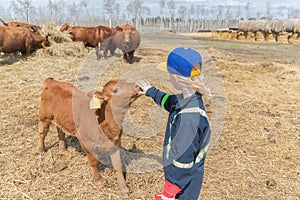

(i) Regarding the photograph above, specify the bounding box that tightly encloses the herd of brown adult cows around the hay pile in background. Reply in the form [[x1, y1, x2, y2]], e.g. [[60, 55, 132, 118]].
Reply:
[[0, 19, 141, 63]]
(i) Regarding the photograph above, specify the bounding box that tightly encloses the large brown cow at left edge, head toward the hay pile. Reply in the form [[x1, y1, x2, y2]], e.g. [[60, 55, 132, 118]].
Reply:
[[0, 26, 50, 56]]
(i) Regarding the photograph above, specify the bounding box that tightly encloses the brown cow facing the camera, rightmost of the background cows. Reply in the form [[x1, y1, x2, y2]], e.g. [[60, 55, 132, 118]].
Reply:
[[109, 24, 141, 63]]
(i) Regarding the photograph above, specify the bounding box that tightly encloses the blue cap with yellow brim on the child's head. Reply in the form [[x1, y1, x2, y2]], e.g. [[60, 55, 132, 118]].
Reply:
[[157, 47, 202, 77]]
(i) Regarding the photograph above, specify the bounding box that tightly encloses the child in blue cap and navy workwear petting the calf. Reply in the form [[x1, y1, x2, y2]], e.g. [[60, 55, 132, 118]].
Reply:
[[137, 48, 210, 200]]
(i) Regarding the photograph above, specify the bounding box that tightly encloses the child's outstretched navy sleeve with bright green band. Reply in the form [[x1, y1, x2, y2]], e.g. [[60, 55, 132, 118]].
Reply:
[[146, 87, 177, 112]]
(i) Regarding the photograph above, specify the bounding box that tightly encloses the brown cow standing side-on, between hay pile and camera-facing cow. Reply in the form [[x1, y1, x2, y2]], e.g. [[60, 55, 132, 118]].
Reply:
[[60, 23, 114, 59]]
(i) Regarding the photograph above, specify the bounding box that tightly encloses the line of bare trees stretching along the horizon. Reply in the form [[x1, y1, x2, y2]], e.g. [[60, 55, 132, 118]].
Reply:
[[0, 0, 300, 32]]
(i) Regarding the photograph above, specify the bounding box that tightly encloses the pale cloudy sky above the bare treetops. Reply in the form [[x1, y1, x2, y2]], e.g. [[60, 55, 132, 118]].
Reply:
[[0, 0, 300, 17]]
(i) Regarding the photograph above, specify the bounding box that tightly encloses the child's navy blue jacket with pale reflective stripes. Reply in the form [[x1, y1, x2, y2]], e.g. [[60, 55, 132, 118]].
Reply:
[[146, 87, 211, 189]]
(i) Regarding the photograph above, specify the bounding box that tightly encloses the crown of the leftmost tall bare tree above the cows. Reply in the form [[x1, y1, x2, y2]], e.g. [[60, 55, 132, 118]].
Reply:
[[10, 0, 36, 23]]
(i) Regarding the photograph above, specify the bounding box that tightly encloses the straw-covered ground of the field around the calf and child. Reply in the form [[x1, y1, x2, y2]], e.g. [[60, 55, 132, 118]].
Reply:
[[0, 33, 300, 200]]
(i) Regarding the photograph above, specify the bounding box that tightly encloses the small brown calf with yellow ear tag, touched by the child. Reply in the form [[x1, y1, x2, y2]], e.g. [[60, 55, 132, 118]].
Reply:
[[38, 78, 140, 195]]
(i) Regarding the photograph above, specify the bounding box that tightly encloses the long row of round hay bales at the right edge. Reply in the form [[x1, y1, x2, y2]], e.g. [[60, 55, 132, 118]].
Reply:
[[212, 18, 300, 43]]
